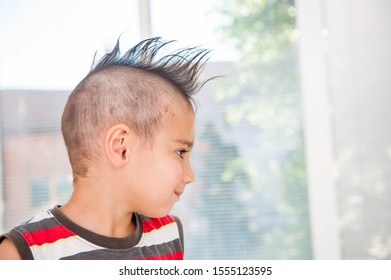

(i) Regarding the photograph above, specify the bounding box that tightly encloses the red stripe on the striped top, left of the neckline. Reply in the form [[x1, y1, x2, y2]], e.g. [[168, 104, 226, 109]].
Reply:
[[23, 226, 75, 246]]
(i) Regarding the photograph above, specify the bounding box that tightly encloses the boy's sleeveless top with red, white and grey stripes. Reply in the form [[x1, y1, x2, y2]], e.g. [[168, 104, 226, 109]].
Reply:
[[0, 206, 183, 260]]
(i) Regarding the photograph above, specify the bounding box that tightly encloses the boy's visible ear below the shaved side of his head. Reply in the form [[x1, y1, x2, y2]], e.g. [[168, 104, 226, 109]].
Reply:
[[105, 124, 131, 167]]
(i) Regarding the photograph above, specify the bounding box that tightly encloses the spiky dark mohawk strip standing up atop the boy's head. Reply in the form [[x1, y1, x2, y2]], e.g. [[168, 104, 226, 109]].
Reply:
[[90, 37, 213, 105]]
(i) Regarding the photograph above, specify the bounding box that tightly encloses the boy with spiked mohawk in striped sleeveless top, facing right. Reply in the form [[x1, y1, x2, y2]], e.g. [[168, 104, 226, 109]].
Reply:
[[0, 38, 213, 259]]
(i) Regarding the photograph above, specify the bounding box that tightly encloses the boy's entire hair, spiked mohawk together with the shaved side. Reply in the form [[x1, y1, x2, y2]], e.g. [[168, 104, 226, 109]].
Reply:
[[61, 38, 213, 180]]
